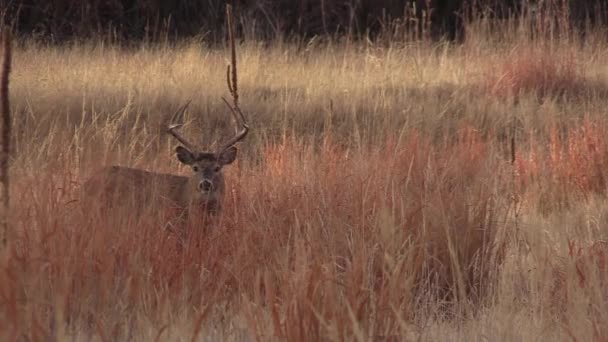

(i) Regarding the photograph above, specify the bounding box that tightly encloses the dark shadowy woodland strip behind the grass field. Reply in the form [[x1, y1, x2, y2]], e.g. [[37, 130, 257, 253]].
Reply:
[[0, 0, 608, 42]]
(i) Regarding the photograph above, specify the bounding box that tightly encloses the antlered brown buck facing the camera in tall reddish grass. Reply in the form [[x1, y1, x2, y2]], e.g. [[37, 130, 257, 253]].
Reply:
[[84, 7, 249, 222]]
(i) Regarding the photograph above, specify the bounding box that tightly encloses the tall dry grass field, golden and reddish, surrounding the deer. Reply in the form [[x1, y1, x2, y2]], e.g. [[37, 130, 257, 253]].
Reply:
[[0, 20, 608, 341]]
